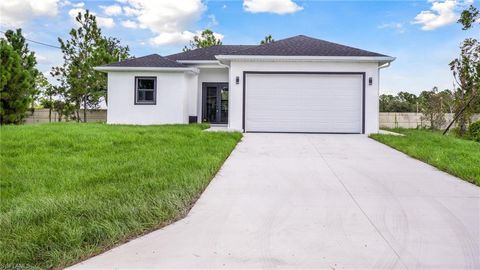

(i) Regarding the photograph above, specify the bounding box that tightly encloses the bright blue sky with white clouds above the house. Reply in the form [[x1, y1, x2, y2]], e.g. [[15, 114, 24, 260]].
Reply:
[[0, 0, 480, 94]]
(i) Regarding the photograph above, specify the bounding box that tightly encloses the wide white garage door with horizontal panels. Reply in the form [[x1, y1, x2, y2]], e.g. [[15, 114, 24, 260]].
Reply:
[[245, 73, 363, 133]]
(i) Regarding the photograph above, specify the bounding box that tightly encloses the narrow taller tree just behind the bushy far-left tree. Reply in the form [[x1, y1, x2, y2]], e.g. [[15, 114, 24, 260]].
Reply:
[[5, 28, 40, 113]]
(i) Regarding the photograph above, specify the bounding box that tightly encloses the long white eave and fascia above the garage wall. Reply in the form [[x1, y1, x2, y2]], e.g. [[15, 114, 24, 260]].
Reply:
[[215, 55, 395, 63]]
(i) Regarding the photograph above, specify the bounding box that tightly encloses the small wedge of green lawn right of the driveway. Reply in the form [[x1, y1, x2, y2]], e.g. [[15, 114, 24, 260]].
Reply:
[[370, 129, 480, 186]]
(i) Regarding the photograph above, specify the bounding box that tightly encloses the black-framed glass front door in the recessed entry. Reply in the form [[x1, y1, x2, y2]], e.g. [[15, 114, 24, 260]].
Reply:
[[202, 83, 228, 124]]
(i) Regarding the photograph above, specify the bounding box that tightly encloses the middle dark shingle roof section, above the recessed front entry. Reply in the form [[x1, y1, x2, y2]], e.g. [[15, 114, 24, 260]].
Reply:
[[166, 45, 257, 61]]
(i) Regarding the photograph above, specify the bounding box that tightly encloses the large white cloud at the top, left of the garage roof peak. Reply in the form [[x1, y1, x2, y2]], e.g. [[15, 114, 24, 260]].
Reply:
[[117, 0, 223, 45]]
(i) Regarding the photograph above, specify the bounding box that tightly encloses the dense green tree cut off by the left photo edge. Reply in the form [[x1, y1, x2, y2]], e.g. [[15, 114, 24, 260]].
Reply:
[[0, 39, 32, 124]]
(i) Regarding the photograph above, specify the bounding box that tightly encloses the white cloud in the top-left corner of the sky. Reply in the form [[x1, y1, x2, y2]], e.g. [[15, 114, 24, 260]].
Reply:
[[0, 0, 59, 27]]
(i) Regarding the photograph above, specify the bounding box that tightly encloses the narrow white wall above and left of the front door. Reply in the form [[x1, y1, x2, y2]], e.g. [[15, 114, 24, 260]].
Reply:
[[195, 67, 228, 123]]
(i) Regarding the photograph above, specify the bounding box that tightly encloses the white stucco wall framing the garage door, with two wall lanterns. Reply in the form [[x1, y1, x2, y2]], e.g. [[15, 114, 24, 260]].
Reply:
[[228, 61, 379, 134]]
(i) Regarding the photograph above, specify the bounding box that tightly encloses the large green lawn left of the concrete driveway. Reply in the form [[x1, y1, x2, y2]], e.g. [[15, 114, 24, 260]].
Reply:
[[0, 123, 242, 269]]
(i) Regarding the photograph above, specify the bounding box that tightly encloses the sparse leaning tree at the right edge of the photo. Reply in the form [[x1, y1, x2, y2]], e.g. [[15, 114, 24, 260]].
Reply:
[[443, 6, 480, 136]]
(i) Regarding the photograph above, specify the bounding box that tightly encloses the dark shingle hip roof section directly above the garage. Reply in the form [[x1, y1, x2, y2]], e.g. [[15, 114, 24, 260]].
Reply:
[[225, 35, 386, 56]]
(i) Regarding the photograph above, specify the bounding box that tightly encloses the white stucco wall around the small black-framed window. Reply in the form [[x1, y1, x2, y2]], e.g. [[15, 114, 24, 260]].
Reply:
[[107, 71, 190, 125]]
